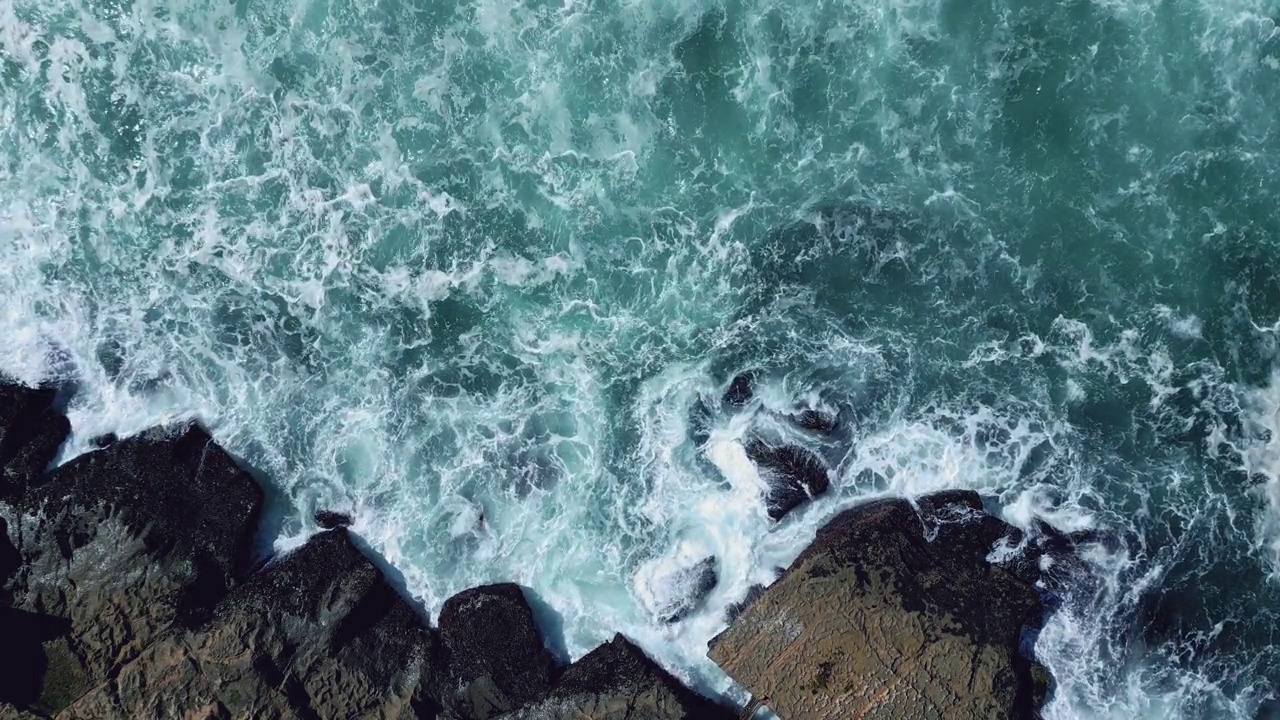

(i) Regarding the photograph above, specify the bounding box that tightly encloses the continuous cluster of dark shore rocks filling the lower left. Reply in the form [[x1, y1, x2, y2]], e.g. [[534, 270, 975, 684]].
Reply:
[[0, 384, 732, 720]]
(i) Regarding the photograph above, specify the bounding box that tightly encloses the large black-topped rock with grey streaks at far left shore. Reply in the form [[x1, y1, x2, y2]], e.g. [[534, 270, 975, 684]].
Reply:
[[0, 428, 262, 712]]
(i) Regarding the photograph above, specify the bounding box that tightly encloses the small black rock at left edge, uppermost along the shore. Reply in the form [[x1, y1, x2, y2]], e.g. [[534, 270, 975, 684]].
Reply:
[[0, 380, 72, 498]]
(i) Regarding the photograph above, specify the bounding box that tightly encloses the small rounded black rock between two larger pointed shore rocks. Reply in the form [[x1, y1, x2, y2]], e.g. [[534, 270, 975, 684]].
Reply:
[[438, 583, 553, 720]]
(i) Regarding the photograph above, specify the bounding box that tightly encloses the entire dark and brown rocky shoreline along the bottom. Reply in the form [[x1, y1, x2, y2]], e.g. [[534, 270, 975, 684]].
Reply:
[[0, 383, 1048, 720]]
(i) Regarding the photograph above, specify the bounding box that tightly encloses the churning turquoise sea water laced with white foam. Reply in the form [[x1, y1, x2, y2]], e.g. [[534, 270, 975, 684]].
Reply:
[[0, 0, 1280, 719]]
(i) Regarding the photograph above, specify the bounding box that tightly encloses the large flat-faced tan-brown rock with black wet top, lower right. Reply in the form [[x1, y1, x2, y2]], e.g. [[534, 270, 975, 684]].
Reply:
[[710, 492, 1047, 720]]
